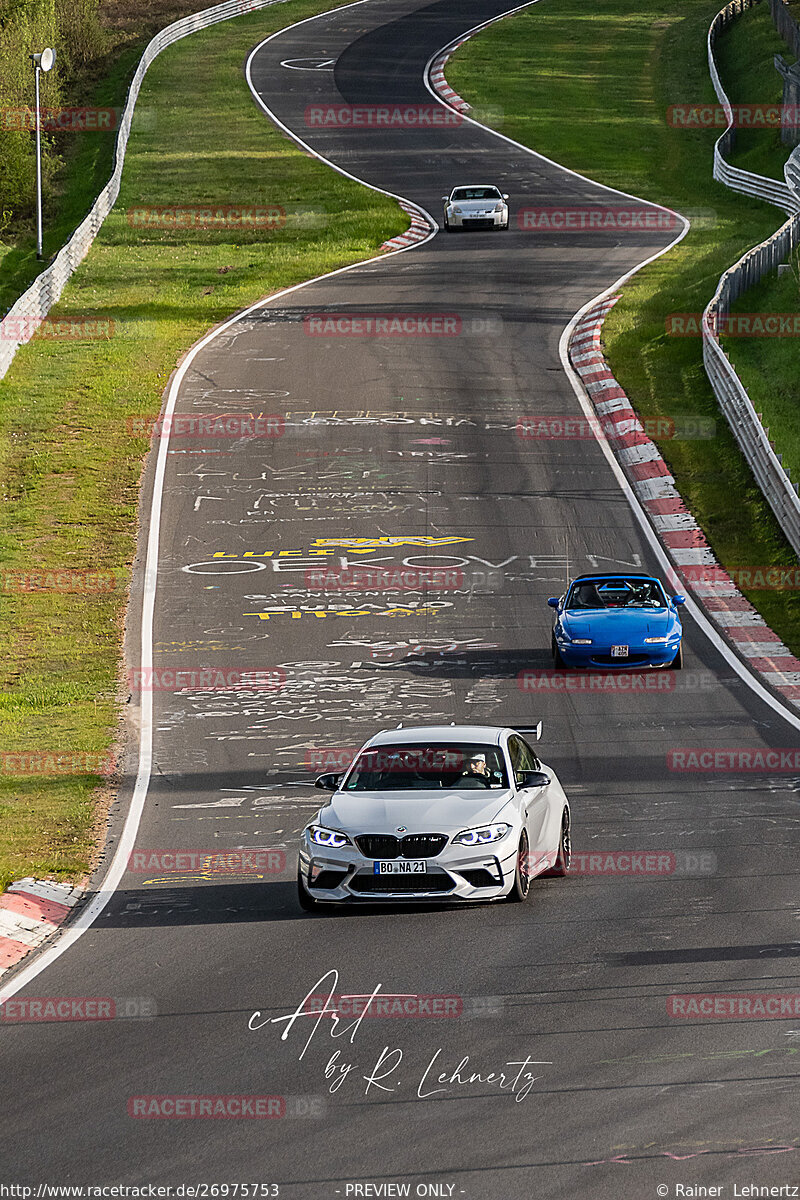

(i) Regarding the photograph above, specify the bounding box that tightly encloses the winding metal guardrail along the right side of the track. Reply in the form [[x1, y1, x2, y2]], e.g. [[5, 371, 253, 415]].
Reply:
[[703, 0, 800, 557]]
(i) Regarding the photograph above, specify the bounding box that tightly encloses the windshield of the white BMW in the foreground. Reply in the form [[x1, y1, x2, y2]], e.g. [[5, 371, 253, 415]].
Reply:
[[343, 742, 509, 792]]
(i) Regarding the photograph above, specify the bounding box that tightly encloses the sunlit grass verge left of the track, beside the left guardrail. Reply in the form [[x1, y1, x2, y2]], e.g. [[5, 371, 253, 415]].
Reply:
[[0, 0, 408, 887]]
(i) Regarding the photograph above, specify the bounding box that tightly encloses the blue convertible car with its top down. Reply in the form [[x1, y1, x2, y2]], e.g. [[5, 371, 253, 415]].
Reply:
[[547, 574, 686, 670]]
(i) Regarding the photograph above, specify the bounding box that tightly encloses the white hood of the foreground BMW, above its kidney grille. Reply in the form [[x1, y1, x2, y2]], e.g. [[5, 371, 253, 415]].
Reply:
[[319, 787, 513, 835]]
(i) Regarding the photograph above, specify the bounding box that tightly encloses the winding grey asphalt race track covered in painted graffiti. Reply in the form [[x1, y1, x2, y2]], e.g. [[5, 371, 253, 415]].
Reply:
[[2, 0, 800, 1200]]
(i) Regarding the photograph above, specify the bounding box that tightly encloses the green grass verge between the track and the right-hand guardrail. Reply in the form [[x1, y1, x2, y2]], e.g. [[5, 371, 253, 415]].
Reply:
[[447, 0, 800, 653]]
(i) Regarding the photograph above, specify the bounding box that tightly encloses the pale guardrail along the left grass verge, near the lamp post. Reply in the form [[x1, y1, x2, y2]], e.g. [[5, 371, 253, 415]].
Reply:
[[0, 0, 283, 379]]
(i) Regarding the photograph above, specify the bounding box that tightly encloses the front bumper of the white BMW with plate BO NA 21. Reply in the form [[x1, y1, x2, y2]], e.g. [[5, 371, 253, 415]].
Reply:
[[299, 830, 519, 904]]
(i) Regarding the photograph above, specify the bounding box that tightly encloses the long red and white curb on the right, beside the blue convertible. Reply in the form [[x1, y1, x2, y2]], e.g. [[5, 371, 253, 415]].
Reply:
[[570, 295, 800, 708]]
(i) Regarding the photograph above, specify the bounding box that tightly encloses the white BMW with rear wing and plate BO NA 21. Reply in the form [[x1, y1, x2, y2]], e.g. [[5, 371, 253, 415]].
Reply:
[[297, 725, 571, 911]]
